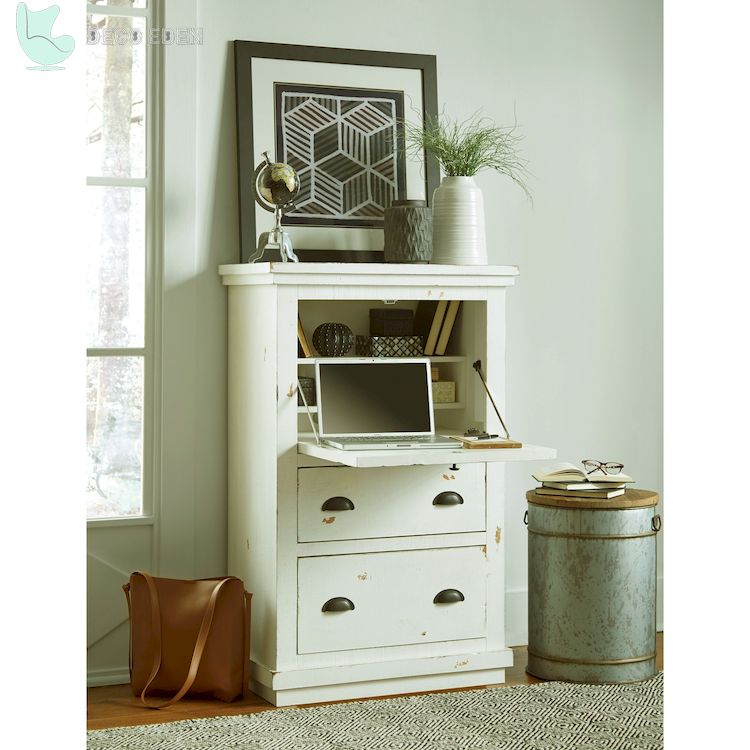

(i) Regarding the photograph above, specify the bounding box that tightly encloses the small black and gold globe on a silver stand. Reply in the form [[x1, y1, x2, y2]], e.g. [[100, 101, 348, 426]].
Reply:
[[249, 151, 300, 263]]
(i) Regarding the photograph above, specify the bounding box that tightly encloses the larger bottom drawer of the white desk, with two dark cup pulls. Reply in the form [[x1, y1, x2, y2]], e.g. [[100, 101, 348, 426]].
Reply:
[[297, 547, 488, 654]]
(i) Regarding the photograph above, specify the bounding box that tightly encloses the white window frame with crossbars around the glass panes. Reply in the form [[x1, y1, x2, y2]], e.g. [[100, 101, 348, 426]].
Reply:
[[86, 0, 164, 528]]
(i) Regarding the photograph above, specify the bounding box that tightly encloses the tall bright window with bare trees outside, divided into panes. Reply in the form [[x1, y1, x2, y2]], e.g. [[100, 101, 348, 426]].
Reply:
[[86, 0, 157, 519]]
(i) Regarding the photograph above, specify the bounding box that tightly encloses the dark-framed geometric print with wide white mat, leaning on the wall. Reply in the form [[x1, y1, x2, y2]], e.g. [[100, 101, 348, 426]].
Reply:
[[234, 41, 440, 262]]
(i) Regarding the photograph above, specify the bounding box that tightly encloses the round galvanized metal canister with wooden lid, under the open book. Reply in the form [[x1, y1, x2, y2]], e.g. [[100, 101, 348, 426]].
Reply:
[[526, 490, 661, 683]]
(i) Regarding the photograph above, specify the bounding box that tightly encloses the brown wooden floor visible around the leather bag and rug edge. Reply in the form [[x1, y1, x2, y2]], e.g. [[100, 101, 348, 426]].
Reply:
[[87, 633, 664, 729]]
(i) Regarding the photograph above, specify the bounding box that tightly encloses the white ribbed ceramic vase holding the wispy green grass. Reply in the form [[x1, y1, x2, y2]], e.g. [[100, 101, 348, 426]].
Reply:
[[432, 177, 487, 266]]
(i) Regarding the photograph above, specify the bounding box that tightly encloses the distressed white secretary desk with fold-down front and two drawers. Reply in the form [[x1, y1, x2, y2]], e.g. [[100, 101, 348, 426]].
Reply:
[[219, 263, 555, 706]]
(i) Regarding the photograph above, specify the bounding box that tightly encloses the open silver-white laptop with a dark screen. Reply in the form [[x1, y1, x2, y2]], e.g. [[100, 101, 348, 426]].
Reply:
[[315, 357, 460, 450]]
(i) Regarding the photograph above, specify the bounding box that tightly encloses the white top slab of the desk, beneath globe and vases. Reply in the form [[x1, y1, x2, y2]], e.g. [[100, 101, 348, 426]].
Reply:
[[219, 263, 518, 286]]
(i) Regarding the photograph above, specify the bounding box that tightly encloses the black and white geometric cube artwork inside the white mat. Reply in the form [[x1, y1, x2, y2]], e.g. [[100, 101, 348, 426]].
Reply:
[[275, 83, 406, 227]]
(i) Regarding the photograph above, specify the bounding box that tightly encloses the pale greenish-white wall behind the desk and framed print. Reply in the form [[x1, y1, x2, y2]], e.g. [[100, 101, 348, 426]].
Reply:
[[162, 0, 662, 644]]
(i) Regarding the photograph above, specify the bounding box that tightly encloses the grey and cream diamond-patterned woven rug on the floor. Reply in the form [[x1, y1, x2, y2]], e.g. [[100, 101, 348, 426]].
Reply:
[[87, 673, 663, 750]]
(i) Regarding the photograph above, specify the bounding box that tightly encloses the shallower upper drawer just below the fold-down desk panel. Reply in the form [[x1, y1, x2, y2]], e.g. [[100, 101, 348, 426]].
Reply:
[[297, 464, 485, 542]]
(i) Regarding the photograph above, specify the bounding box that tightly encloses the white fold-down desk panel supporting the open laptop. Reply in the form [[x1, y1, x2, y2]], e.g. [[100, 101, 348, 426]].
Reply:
[[297, 436, 557, 469]]
